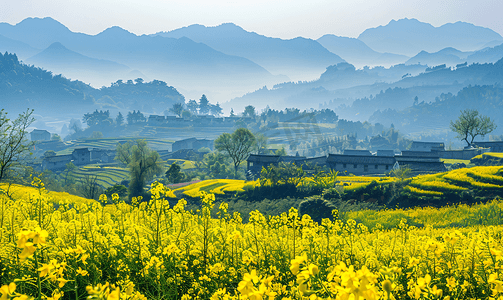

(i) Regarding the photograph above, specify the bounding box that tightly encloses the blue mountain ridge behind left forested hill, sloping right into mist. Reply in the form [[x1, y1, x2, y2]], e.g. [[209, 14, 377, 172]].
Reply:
[[0, 18, 287, 101]]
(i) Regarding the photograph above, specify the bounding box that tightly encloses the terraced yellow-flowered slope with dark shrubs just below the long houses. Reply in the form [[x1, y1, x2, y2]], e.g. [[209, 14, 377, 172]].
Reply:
[[173, 166, 503, 206]]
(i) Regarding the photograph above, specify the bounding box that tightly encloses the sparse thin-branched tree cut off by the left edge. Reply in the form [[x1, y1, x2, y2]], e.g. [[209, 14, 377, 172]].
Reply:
[[0, 109, 35, 182]]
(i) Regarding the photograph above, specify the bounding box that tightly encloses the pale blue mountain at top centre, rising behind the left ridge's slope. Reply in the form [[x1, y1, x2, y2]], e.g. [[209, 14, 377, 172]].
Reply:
[[155, 23, 344, 81]]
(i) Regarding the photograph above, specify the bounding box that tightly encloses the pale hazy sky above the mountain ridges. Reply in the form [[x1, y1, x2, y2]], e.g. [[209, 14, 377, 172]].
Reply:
[[0, 0, 503, 39]]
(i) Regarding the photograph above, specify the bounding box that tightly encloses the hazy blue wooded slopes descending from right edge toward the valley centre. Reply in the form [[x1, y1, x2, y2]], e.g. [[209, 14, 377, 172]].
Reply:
[[227, 55, 503, 116]]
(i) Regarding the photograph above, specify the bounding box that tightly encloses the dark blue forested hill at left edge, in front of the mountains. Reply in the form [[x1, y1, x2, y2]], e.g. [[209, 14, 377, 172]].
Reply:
[[0, 53, 185, 116]]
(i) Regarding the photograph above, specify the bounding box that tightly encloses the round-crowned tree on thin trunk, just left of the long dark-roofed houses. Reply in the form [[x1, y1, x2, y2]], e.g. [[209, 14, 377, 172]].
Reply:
[[215, 128, 255, 177]]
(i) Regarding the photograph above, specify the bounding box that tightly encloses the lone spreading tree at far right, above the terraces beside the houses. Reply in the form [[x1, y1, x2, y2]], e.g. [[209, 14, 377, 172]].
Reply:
[[450, 109, 496, 146]]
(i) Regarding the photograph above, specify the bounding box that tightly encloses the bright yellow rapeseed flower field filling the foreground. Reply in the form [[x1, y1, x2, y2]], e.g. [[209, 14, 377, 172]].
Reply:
[[0, 180, 503, 300]]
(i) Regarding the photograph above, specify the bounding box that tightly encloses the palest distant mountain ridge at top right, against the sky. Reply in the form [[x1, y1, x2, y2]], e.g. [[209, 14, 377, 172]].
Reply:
[[358, 18, 503, 56]]
